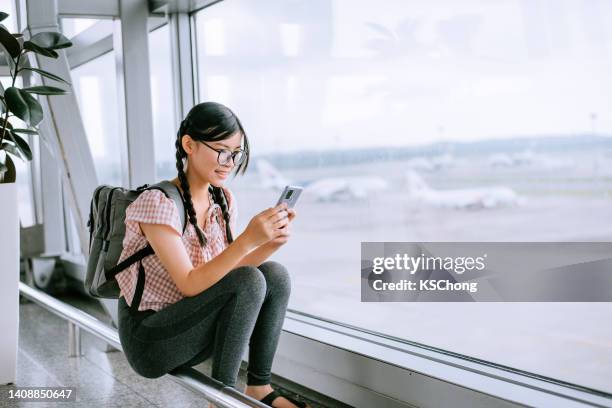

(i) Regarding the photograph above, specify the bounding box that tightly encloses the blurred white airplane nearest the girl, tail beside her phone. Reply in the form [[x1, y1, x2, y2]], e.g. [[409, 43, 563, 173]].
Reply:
[[257, 159, 389, 201]]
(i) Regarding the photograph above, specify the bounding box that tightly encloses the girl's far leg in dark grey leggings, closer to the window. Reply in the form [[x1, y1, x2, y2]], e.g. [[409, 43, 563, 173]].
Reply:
[[247, 261, 291, 385]]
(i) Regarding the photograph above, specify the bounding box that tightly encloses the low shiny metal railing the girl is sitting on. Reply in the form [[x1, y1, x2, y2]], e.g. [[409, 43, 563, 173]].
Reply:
[[19, 282, 269, 408]]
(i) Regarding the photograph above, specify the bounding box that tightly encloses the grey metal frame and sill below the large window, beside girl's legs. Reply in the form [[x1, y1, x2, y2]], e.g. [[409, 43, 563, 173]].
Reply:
[[274, 311, 612, 407]]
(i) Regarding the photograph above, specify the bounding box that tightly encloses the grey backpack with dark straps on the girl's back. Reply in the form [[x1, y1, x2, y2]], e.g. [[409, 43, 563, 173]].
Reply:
[[85, 180, 187, 302]]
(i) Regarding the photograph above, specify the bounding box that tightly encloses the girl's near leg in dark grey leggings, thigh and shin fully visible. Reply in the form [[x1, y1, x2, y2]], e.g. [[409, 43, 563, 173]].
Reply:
[[119, 266, 266, 387]]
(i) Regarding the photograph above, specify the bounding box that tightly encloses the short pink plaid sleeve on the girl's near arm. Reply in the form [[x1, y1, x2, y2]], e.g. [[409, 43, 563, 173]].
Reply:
[[125, 190, 182, 235]]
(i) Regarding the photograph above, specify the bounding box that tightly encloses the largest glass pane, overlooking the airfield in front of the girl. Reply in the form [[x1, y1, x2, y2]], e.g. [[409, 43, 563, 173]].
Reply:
[[196, 0, 612, 392]]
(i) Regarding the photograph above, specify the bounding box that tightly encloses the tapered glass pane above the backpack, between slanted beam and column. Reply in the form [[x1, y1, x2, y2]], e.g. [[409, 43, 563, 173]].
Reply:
[[71, 51, 125, 186]]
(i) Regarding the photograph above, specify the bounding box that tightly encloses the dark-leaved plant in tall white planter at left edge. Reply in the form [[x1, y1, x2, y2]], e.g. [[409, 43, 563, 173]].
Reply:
[[0, 12, 72, 384]]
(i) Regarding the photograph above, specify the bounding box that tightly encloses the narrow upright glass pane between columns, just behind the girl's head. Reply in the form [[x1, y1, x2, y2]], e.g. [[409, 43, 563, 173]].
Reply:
[[149, 25, 178, 180]]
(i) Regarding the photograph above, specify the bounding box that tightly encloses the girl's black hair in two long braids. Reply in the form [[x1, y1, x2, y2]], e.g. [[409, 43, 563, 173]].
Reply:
[[175, 102, 249, 247]]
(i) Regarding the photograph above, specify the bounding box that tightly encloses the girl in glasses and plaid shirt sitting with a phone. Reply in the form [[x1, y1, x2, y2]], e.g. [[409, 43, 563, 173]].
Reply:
[[116, 102, 309, 408]]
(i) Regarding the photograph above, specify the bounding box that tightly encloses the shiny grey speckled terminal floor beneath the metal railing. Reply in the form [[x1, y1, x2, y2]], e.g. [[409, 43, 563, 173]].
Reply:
[[0, 295, 346, 408]]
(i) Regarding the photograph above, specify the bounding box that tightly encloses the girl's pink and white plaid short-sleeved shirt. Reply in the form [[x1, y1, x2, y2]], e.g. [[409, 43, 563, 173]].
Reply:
[[115, 187, 237, 311]]
